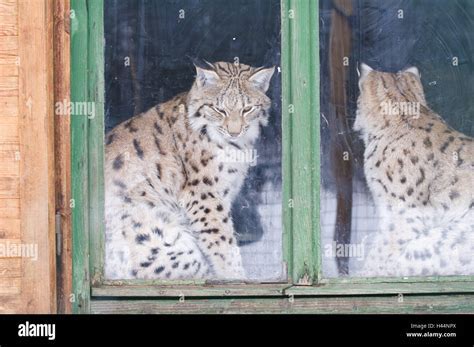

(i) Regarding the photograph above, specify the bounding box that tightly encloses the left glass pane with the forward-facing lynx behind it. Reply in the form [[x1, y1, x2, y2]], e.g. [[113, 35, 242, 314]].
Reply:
[[105, 0, 286, 281]]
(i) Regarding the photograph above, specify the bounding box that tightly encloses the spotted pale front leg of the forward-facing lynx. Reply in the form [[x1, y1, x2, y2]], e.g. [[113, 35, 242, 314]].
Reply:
[[186, 191, 246, 280]]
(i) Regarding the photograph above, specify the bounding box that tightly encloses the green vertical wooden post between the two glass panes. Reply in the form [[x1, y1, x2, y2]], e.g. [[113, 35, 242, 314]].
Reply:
[[289, 0, 319, 285]]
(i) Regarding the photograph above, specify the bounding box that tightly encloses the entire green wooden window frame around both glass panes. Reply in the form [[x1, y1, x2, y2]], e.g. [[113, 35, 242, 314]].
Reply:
[[71, 0, 474, 313]]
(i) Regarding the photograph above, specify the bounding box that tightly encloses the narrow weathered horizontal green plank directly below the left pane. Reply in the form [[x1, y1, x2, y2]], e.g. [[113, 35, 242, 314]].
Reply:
[[92, 284, 289, 297]]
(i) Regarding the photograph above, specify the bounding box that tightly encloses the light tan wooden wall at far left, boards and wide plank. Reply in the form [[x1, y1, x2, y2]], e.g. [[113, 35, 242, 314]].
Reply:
[[0, 0, 56, 313]]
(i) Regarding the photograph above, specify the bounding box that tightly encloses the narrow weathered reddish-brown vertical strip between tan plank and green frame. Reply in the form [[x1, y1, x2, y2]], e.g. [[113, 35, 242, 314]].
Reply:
[[53, 0, 72, 313]]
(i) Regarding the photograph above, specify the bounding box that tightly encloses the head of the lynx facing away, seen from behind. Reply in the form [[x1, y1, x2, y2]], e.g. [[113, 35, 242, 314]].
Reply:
[[354, 63, 426, 142]]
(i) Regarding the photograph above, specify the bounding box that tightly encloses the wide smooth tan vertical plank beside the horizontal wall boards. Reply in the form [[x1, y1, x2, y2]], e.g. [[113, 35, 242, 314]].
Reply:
[[18, 0, 56, 313]]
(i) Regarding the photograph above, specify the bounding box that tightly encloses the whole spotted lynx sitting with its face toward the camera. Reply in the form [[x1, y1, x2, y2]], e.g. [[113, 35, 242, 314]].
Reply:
[[105, 62, 274, 279]]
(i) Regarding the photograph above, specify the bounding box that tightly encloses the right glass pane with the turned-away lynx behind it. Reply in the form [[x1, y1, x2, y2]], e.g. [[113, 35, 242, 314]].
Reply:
[[320, 0, 474, 277]]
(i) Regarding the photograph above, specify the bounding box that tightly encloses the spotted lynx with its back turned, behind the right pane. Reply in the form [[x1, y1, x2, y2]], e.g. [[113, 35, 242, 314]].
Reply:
[[354, 64, 474, 276]]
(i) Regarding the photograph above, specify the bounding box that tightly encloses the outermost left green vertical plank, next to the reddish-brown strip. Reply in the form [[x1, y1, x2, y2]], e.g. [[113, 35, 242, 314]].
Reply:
[[71, 0, 91, 313]]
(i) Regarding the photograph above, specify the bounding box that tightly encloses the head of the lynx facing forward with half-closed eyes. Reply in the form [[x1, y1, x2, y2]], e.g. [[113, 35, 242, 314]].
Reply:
[[188, 62, 275, 144]]
